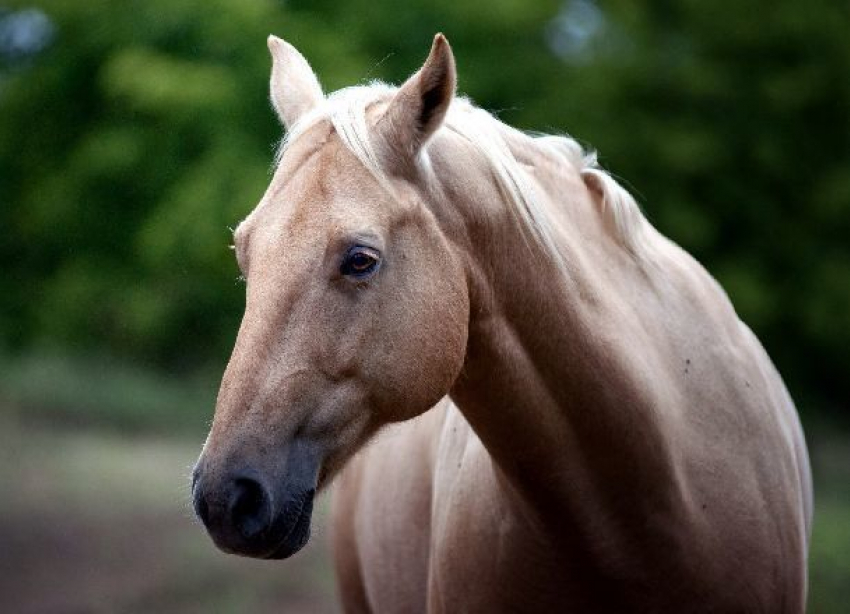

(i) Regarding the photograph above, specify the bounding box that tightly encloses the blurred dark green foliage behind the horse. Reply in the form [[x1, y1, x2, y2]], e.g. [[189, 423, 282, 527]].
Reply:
[[0, 0, 850, 418]]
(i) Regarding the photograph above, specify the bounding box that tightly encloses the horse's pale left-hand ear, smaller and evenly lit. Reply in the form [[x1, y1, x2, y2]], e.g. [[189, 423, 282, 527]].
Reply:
[[268, 35, 325, 130]]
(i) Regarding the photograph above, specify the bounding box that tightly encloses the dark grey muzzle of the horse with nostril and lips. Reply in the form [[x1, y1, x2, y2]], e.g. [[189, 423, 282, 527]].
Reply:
[[192, 445, 318, 559]]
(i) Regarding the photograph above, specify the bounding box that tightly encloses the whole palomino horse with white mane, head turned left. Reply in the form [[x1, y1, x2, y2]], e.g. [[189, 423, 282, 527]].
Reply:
[[193, 35, 812, 613]]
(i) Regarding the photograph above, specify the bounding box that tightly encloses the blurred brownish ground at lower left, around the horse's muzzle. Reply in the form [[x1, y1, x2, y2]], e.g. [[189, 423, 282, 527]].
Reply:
[[0, 419, 338, 614]]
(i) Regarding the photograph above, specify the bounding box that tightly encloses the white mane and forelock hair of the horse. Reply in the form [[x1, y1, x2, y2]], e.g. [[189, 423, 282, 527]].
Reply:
[[275, 82, 647, 265]]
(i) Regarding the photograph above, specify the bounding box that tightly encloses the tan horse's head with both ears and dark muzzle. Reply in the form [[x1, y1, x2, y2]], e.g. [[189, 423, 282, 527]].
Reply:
[[193, 35, 469, 558]]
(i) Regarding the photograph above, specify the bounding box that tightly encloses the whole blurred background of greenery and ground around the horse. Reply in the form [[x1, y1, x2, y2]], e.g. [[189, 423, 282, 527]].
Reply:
[[0, 0, 850, 612]]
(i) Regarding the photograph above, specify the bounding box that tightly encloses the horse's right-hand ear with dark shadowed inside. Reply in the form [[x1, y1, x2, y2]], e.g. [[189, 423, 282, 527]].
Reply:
[[379, 34, 457, 155]]
